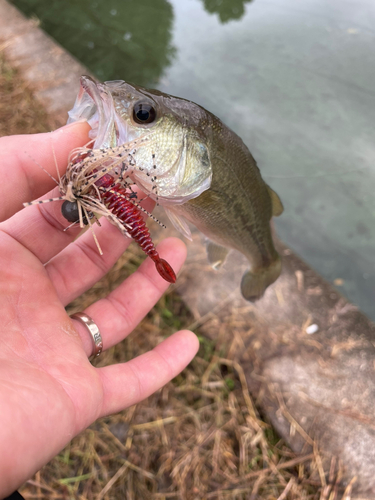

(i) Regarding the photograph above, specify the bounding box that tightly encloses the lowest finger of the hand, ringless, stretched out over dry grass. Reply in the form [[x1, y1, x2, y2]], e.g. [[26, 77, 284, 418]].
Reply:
[[98, 330, 199, 416]]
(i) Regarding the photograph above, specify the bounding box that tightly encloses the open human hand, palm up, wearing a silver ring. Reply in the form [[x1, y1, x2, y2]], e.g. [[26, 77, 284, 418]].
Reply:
[[0, 123, 198, 498]]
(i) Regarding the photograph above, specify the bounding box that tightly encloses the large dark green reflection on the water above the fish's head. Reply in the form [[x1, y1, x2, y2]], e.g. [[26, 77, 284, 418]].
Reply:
[[12, 0, 175, 85]]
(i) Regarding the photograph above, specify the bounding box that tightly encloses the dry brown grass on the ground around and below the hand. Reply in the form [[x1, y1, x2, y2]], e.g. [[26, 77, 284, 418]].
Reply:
[[0, 51, 350, 500]]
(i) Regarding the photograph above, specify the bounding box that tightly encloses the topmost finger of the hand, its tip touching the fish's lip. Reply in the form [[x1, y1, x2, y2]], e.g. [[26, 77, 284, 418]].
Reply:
[[0, 122, 90, 221]]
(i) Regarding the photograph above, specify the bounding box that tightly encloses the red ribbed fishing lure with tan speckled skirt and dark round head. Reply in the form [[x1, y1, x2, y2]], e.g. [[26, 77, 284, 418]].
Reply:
[[24, 145, 176, 283]]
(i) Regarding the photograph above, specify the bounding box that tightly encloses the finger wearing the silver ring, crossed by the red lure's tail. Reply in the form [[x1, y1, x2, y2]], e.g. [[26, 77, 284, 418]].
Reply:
[[70, 238, 186, 356]]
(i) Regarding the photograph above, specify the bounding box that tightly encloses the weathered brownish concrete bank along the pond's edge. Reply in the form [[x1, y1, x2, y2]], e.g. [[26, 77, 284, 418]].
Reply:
[[0, 0, 375, 498]]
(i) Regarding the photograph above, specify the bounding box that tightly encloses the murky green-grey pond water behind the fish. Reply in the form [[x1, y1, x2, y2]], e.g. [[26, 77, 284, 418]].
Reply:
[[9, 0, 375, 319]]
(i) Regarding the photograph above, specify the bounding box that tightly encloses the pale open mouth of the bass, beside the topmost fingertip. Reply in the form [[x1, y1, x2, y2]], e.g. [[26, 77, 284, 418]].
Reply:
[[67, 76, 118, 149]]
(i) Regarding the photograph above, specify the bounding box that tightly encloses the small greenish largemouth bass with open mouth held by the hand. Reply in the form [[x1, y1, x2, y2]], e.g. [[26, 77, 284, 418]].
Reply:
[[68, 76, 283, 302]]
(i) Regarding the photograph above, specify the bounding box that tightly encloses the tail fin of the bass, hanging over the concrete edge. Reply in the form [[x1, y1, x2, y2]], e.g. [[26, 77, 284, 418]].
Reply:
[[241, 256, 281, 302]]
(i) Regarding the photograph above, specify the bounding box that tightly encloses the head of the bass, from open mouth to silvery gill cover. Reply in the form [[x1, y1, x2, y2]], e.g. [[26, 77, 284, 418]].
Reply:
[[68, 76, 212, 206]]
